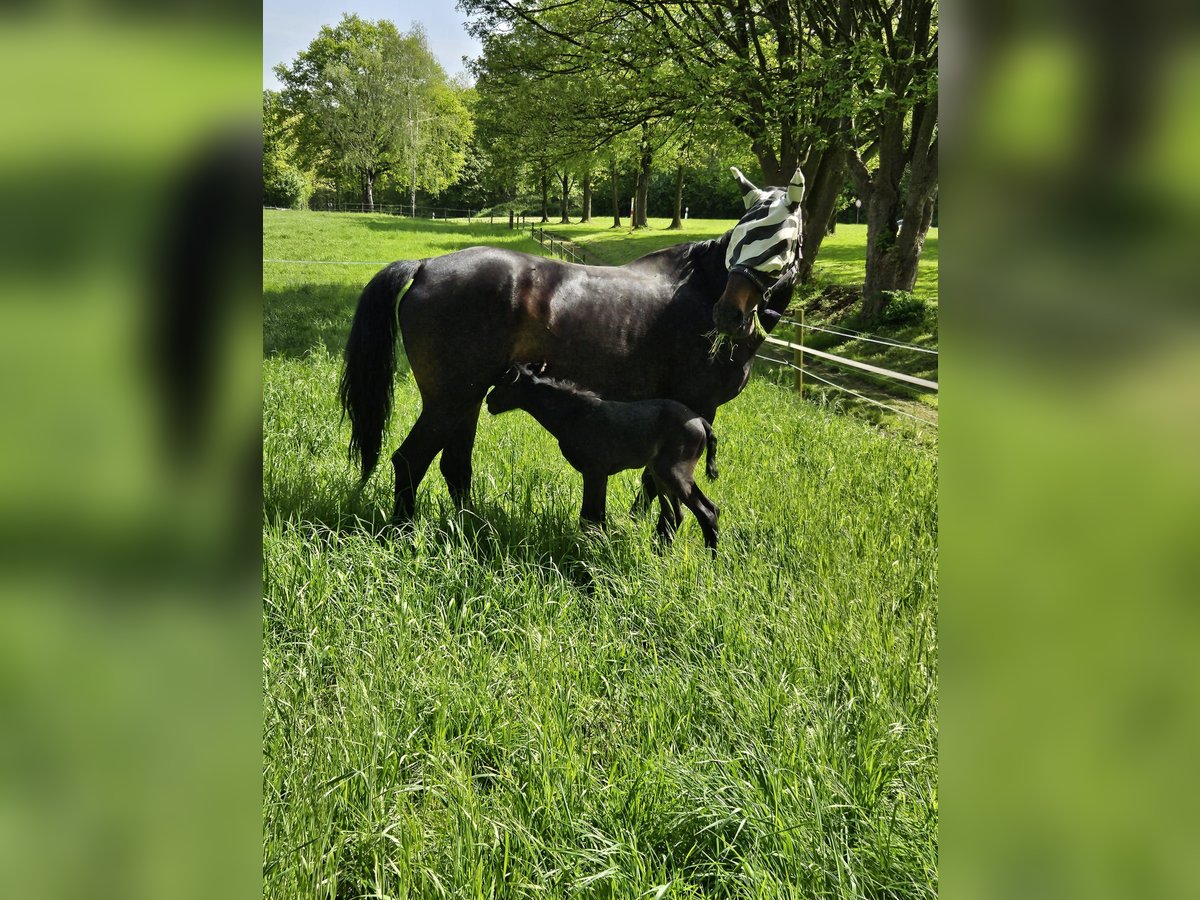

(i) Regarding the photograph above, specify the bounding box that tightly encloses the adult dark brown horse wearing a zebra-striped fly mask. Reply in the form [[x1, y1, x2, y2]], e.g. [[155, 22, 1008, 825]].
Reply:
[[340, 168, 804, 523]]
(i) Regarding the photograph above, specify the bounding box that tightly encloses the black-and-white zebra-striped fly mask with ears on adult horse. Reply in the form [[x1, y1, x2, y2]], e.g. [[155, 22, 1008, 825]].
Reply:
[[725, 168, 804, 275]]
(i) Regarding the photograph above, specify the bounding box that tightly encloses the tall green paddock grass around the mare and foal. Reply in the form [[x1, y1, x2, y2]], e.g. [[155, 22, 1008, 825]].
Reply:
[[263, 211, 937, 898]]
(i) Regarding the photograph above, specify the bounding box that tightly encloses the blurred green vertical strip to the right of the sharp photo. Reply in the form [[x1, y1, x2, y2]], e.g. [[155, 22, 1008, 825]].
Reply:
[[940, 4, 1200, 898]]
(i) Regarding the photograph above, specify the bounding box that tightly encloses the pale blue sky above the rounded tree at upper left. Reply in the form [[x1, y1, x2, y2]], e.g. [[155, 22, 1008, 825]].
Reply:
[[263, 0, 480, 90]]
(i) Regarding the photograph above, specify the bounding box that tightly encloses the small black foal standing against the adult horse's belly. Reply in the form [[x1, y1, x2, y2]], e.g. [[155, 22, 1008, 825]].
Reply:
[[487, 366, 720, 553]]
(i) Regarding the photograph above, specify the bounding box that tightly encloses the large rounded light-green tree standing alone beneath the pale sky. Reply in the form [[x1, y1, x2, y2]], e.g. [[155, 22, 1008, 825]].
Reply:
[[275, 14, 470, 211]]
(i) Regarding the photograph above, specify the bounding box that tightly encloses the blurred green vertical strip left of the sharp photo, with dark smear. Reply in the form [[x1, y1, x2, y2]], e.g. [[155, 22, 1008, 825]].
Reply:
[[0, 5, 262, 898]]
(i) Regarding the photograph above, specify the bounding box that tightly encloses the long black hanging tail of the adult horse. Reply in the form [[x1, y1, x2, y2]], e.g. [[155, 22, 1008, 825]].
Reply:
[[338, 259, 422, 482]]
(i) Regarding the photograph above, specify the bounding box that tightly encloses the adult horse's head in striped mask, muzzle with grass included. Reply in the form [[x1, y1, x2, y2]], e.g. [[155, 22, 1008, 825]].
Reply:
[[713, 168, 804, 337]]
